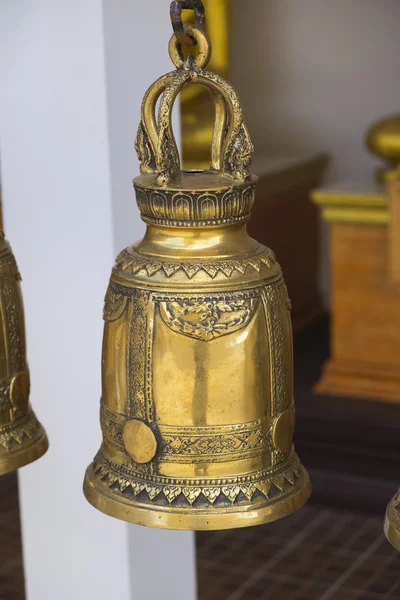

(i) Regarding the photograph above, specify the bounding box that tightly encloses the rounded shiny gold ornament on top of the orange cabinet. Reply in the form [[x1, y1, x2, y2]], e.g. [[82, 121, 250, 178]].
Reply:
[[367, 115, 400, 181]]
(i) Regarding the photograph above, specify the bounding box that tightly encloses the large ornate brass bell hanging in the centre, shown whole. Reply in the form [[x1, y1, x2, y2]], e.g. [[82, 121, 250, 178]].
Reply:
[[84, 2, 310, 530]]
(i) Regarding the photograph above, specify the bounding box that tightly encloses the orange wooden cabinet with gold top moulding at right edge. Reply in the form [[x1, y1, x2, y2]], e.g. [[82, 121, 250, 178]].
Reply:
[[313, 182, 400, 402]]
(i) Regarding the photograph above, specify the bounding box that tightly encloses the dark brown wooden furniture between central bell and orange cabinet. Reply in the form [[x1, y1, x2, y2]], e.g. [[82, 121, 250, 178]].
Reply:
[[248, 152, 328, 329]]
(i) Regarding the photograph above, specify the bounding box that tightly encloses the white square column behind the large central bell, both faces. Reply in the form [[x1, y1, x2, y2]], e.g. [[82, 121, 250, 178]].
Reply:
[[0, 0, 195, 600]]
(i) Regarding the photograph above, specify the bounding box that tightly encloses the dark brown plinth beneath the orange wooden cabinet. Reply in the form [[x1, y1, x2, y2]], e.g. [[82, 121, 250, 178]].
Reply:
[[295, 317, 400, 512]]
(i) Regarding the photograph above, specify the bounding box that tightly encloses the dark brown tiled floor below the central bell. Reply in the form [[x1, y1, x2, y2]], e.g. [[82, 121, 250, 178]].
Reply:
[[197, 506, 400, 600]]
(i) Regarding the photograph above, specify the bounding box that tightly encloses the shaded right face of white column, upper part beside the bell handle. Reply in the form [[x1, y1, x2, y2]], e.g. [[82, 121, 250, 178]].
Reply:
[[103, 0, 180, 253]]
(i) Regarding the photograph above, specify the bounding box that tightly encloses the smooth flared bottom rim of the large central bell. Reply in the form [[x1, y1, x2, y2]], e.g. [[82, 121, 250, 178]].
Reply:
[[83, 465, 311, 531]]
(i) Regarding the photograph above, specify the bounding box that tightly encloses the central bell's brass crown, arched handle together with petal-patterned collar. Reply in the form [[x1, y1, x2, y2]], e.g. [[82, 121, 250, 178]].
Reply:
[[134, 25, 257, 227]]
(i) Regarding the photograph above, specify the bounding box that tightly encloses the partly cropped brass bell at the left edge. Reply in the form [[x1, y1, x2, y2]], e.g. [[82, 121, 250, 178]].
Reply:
[[0, 231, 48, 475]]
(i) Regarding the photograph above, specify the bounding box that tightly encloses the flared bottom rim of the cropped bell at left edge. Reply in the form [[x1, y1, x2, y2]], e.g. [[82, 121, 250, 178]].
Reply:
[[0, 412, 49, 476]]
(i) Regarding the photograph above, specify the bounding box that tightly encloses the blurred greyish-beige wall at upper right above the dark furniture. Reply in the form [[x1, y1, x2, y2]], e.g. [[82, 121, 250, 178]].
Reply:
[[232, 0, 400, 179]]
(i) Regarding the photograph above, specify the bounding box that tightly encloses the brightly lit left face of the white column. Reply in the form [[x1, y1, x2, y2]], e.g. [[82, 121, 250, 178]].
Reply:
[[0, 0, 130, 600]]
